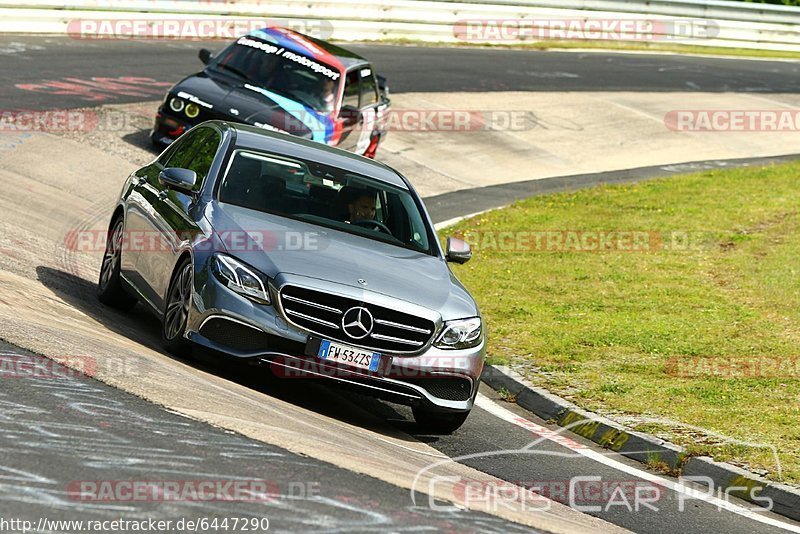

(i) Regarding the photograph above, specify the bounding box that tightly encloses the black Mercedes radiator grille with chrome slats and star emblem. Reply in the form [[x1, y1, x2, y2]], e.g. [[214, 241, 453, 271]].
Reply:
[[280, 286, 436, 354]]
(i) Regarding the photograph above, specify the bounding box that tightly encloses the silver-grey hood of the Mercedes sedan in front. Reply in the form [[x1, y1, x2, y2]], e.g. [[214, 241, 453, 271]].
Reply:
[[207, 202, 477, 320]]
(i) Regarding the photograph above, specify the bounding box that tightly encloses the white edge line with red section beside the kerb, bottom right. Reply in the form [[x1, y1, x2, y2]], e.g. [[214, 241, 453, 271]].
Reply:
[[475, 394, 800, 533]]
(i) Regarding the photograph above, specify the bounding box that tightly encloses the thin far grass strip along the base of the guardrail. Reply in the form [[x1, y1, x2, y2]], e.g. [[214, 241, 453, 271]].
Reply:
[[358, 39, 800, 59]]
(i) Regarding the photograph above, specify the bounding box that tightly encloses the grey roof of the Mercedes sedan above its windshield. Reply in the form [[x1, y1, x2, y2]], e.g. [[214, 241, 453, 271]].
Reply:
[[217, 121, 410, 190]]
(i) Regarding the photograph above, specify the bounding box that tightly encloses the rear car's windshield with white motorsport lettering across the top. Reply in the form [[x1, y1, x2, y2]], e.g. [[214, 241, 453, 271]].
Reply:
[[209, 37, 341, 114]]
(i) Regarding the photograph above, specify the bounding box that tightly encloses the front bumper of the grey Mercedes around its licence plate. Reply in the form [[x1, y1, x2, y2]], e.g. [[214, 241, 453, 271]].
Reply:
[[186, 271, 486, 412]]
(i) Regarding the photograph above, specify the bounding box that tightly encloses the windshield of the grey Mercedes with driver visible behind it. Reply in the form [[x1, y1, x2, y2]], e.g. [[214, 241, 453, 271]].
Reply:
[[218, 150, 432, 254]]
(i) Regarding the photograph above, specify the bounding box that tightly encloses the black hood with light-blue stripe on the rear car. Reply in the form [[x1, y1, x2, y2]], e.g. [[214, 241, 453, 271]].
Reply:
[[172, 71, 334, 142]]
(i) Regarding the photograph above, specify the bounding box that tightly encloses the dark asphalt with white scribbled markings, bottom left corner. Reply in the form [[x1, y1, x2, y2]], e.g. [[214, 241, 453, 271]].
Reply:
[[0, 351, 530, 532]]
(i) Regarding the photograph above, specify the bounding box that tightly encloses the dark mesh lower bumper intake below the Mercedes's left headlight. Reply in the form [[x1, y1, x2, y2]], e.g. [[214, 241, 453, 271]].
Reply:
[[200, 317, 305, 356]]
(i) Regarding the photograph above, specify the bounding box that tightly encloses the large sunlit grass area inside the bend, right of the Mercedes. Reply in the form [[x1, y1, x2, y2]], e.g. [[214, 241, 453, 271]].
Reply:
[[442, 163, 800, 484]]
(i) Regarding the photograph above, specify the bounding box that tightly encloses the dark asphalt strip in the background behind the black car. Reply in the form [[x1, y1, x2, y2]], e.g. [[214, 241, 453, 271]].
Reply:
[[0, 36, 800, 109]]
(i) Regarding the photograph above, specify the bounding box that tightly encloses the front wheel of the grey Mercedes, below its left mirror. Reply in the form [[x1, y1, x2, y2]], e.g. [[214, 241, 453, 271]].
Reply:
[[161, 258, 194, 357]]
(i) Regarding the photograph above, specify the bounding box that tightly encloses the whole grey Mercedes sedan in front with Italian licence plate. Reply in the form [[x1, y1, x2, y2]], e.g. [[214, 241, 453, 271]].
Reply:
[[98, 121, 486, 433]]
